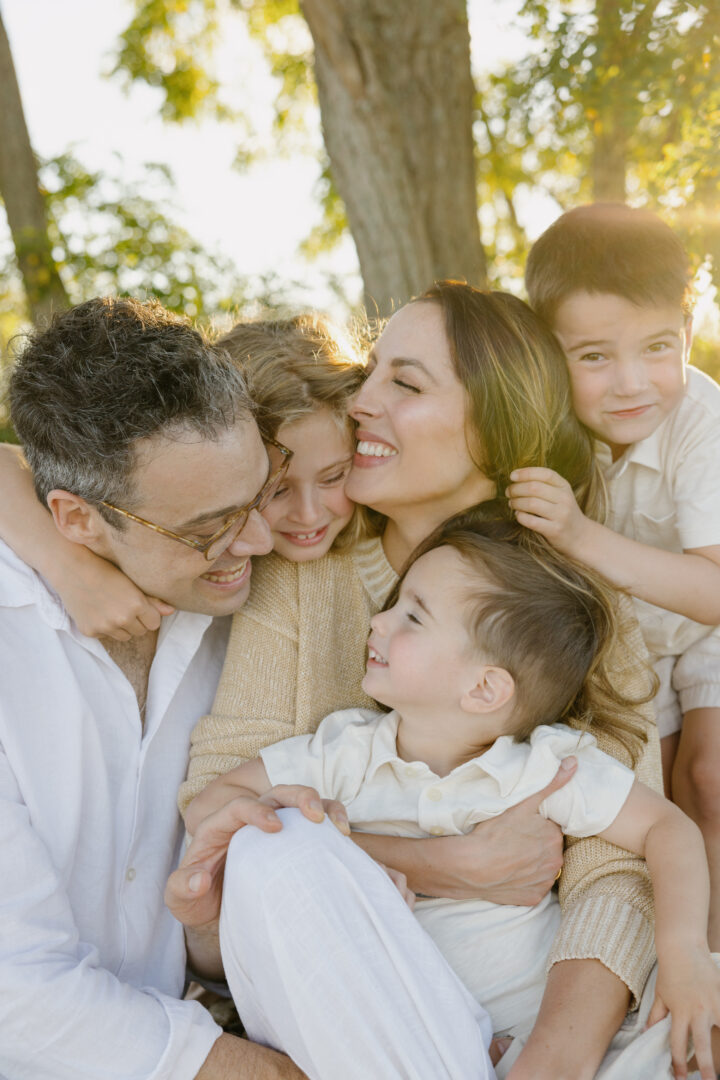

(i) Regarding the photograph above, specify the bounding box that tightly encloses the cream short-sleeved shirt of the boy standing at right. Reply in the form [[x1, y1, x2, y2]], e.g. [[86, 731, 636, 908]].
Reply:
[[596, 367, 720, 657]]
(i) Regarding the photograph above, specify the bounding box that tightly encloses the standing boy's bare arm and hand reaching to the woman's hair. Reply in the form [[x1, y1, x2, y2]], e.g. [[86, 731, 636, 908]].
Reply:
[[505, 469, 720, 626]]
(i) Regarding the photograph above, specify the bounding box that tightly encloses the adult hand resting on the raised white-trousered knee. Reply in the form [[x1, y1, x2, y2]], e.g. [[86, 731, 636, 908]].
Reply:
[[165, 784, 350, 930]]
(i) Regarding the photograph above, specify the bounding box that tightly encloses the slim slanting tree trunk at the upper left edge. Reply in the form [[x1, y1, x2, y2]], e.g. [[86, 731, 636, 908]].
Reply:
[[0, 16, 69, 323]]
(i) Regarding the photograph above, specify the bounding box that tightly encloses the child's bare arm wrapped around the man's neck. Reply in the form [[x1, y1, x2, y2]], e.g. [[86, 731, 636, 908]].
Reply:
[[0, 444, 174, 640]]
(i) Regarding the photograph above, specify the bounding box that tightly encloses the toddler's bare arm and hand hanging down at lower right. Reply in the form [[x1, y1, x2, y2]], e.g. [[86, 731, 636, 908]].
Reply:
[[600, 781, 720, 1080]]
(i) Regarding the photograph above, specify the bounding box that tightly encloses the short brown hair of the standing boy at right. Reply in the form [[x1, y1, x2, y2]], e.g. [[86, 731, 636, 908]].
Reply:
[[525, 203, 693, 325]]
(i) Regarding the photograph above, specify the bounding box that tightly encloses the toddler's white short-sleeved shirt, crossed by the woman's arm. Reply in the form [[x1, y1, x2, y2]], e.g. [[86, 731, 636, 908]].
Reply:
[[260, 708, 635, 1036]]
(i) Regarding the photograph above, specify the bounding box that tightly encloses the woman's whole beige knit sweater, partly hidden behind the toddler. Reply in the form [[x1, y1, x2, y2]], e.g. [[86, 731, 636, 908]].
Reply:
[[179, 539, 662, 1000]]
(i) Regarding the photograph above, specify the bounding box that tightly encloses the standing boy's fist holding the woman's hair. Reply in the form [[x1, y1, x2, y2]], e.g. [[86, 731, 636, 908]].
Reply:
[[505, 468, 594, 558]]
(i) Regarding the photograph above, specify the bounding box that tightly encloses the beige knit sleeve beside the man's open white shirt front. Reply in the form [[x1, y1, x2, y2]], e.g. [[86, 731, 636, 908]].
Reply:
[[178, 555, 306, 813]]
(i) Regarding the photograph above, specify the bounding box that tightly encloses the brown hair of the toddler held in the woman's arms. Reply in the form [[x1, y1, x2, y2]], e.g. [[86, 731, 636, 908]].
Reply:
[[386, 503, 653, 762]]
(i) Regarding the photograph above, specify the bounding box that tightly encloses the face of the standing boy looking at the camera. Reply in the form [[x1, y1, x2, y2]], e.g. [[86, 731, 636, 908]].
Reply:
[[553, 292, 691, 460]]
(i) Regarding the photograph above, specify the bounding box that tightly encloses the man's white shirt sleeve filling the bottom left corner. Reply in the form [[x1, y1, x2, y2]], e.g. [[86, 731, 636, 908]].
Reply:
[[0, 747, 221, 1080]]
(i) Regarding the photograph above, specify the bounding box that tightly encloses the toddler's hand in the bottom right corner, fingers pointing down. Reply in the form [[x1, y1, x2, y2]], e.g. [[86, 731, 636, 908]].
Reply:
[[648, 944, 720, 1080]]
